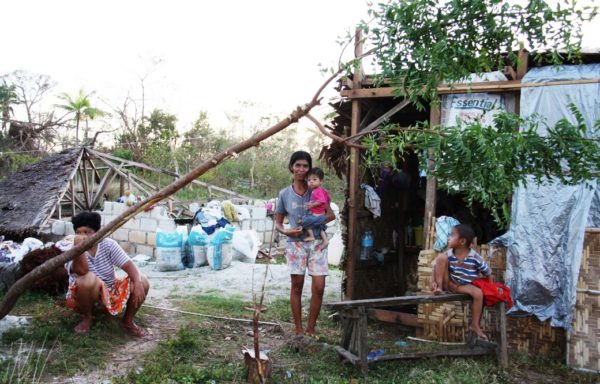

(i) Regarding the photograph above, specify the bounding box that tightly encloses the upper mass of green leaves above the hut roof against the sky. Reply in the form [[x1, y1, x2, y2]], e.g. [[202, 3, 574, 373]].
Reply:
[[362, 0, 596, 107]]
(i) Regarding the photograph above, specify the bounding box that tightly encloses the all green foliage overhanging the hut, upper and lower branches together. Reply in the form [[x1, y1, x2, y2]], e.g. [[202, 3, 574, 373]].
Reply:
[[352, 0, 600, 225]]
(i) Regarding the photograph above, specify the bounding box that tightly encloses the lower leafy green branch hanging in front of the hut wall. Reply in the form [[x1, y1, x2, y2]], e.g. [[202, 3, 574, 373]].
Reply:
[[365, 104, 600, 226]]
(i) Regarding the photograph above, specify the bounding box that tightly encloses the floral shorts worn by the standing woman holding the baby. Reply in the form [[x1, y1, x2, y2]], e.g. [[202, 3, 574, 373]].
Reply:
[[285, 240, 329, 276]]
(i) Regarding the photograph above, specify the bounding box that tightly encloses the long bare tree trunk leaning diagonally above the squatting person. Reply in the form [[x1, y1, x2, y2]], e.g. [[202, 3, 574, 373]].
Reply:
[[0, 100, 322, 319]]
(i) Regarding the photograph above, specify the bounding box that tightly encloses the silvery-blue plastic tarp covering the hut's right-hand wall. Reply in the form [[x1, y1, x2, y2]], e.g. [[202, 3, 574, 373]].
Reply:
[[497, 64, 600, 329]]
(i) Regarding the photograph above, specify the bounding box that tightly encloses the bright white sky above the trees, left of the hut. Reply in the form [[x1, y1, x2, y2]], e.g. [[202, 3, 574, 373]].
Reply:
[[0, 0, 367, 130]]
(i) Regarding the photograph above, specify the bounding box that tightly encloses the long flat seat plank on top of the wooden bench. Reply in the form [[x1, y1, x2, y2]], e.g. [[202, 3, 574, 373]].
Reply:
[[323, 293, 471, 310]]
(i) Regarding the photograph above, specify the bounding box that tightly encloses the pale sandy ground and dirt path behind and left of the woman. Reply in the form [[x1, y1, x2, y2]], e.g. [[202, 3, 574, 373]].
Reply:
[[51, 261, 342, 384]]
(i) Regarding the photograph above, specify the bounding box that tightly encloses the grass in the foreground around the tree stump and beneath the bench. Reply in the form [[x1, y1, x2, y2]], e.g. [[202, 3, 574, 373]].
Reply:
[[116, 294, 598, 384]]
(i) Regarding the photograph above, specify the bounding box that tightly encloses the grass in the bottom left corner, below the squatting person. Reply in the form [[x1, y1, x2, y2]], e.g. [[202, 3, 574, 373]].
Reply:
[[0, 292, 150, 382]]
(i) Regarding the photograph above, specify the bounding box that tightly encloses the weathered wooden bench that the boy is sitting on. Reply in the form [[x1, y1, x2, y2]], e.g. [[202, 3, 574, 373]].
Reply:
[[324, 293, 508, 373]]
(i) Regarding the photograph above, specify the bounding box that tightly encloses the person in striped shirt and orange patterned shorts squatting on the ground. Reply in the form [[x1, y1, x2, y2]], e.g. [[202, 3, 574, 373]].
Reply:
[[65, 212, 150, 337]]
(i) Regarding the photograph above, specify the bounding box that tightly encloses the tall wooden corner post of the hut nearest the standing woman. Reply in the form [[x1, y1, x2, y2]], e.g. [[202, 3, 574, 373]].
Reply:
[[346, 28, 363, 299]]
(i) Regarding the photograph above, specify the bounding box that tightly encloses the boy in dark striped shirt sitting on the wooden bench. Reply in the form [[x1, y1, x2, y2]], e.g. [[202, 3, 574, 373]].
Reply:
[[431, 224, 492, 340]]
